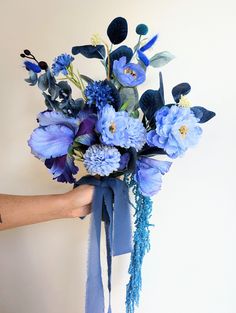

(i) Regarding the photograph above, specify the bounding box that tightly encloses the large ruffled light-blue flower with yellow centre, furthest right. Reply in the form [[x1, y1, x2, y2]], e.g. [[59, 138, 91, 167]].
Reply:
[[147, 105, 202, 158]]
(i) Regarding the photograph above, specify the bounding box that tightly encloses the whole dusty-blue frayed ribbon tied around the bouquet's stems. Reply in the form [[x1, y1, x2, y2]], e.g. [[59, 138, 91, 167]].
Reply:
[[74, 176, 132, 313]]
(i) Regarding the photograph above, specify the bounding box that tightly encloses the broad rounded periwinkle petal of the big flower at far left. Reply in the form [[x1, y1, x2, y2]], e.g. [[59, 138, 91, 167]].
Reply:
[[28, 125, 74, 159]]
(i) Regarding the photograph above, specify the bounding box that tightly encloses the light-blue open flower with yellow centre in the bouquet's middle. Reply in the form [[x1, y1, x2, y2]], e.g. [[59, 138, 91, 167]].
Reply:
[[96, 105, 129, 147]]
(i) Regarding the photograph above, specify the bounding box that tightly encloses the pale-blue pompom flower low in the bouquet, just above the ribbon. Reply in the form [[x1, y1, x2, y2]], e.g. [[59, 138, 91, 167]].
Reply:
[[84, 145, 121, 176]]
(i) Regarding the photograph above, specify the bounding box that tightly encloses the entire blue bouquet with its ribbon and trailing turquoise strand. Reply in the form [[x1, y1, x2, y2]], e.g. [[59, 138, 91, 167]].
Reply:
[[21, 17, 215, 313]]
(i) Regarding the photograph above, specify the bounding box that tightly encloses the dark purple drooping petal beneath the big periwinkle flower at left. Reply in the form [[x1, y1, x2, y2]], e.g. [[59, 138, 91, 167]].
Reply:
[[45, 155, 79, 184]]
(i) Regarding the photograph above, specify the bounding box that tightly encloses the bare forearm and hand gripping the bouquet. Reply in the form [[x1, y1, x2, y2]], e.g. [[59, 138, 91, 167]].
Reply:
[[0, 185, 94, 230]]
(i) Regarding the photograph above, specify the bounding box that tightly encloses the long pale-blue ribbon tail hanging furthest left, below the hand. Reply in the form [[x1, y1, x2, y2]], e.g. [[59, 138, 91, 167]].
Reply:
[[85, 186, 104, 313]]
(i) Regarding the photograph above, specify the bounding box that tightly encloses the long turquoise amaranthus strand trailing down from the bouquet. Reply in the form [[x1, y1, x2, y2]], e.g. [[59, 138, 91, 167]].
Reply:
[[125, 175, 154, 313]]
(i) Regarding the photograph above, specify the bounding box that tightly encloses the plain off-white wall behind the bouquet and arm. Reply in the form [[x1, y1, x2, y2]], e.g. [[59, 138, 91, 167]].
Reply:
[[0, 0, 236, 313]]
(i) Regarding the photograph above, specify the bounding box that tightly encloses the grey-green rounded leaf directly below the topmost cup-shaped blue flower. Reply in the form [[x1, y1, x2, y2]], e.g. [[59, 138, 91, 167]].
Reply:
[[119, 87, 139, 113]]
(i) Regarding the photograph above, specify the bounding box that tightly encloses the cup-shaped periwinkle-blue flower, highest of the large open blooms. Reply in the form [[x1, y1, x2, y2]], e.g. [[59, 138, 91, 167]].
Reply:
[[113, 57, 146, 87]]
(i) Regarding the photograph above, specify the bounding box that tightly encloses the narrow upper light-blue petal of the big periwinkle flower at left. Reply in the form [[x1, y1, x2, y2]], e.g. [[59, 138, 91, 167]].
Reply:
[[37, 111, 79, 132]]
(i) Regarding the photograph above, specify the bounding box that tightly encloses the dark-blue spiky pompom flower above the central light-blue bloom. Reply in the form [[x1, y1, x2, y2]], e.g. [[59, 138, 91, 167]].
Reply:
[[84, 81, 114, 110]]
